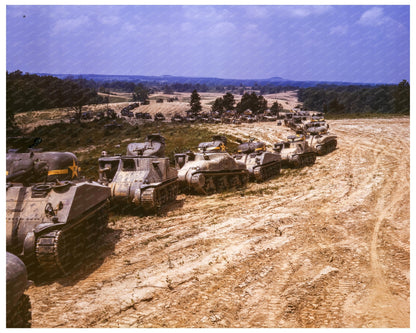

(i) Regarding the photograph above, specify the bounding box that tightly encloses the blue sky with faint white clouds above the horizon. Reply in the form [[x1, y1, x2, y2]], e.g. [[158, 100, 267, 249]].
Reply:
[[6, 4, 410, 84]]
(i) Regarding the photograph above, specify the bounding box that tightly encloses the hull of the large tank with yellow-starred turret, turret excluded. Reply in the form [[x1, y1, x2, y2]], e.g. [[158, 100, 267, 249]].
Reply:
[[6, 181, 110, 275]]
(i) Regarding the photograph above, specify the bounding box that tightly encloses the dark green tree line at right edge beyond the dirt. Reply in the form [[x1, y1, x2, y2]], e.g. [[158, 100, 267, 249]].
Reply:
[[298, 80, 410, 115]]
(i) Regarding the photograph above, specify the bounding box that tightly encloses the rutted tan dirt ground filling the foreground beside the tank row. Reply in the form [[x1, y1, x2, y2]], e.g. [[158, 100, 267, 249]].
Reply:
[[29, 118, 410, 327]]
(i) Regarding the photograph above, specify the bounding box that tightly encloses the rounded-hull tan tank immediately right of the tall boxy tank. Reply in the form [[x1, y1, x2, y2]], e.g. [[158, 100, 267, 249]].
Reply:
[[175, 136, 249, 194]]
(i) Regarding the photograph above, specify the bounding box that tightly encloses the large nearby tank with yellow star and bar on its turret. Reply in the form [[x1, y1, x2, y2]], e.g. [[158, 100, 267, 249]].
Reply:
[[6, 148, 110, 275]]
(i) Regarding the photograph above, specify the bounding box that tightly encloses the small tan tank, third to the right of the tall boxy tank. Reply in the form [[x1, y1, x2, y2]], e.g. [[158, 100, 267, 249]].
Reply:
[[273, 134, 316, 168]]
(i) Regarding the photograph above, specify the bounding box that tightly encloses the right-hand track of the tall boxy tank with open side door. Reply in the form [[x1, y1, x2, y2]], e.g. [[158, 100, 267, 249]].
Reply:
[[140, 180, 178, 210]]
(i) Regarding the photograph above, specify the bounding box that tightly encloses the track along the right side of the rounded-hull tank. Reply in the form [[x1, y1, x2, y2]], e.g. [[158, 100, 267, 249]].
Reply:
[[190, 172, 249, 194]]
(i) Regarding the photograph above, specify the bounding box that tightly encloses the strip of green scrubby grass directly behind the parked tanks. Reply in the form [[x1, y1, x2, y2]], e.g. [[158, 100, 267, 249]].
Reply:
[[16, 119, 238, 179]]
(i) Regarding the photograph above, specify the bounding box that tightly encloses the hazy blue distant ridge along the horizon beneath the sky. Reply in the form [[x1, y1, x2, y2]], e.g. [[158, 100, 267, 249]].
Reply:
[[34, 73, 376, 88]]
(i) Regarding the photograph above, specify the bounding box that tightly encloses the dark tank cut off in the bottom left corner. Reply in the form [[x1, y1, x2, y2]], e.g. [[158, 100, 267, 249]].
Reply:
[[6, 252, 32, 328]]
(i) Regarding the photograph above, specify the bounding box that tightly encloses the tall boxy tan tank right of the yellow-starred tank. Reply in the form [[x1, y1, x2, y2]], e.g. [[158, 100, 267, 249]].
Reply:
[[99, 134, 178, 210]]
